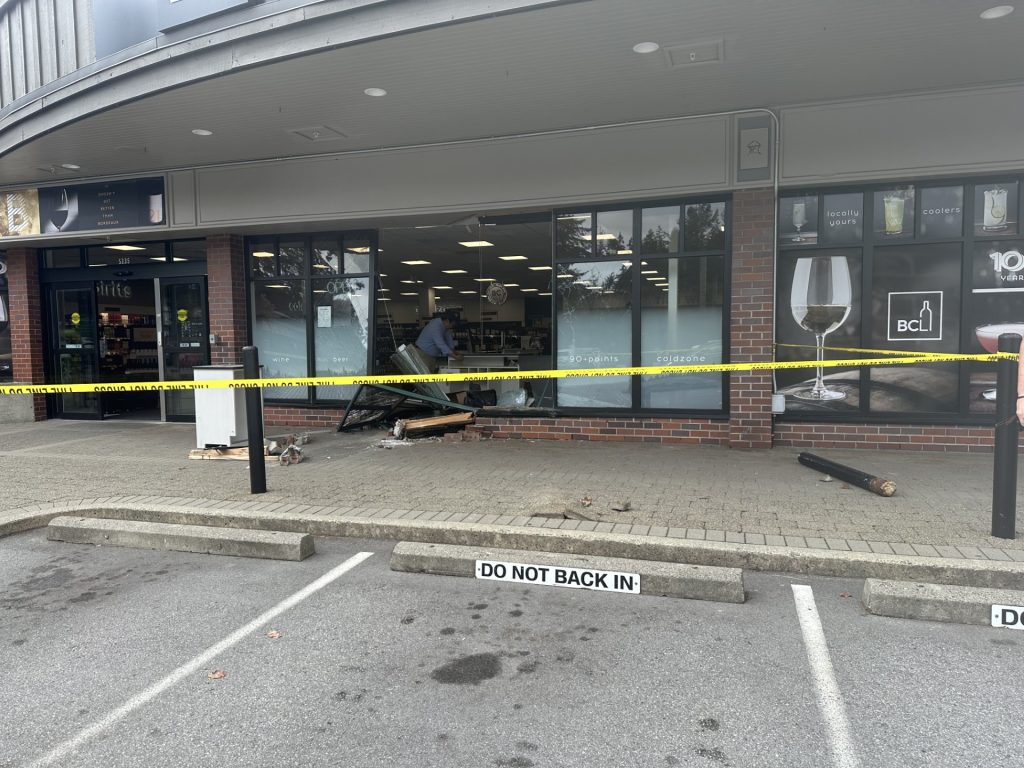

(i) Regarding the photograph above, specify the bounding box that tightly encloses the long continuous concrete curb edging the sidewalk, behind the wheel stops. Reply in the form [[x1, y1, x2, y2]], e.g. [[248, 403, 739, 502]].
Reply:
[[0, 505, 1024, 589]]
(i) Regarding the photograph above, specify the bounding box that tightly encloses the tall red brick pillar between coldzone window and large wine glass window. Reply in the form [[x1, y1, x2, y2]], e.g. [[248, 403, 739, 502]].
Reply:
[[729, 187, 775, 449]]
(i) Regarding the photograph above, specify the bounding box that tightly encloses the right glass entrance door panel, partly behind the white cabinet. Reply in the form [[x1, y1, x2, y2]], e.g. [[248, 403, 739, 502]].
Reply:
[[159, 276, 210, 421]]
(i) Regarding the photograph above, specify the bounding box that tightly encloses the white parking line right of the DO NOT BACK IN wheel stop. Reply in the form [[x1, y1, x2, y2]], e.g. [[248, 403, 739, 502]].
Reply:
[[793, 584, 860, 768]]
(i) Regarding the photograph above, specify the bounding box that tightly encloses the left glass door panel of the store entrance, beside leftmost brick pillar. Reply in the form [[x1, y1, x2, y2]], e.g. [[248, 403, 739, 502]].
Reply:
[[50, 283, 101, 419]]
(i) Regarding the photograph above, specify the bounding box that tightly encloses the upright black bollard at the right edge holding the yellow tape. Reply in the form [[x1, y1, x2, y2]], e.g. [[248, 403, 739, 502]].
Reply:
[[992, 334, 1021, 539]]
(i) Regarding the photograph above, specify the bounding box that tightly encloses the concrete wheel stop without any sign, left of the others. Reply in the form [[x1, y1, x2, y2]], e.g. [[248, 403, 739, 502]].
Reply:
[[46, 516, 314, 561]]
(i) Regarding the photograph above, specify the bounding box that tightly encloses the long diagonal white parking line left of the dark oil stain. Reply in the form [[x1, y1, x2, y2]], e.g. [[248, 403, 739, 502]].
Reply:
[[28, 552, 374, 768]]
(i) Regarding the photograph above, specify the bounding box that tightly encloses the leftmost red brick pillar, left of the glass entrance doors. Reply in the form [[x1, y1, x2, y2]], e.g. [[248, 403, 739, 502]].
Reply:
[[7, 248, 46, 421]]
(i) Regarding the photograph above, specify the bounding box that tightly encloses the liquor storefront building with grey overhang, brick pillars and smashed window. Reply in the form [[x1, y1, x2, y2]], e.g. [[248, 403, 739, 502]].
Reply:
[[0, 0, 1024, 451]]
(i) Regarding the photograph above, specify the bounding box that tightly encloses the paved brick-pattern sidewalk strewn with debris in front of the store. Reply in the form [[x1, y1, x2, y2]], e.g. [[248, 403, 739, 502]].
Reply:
[[0, 421, 1024, 563]]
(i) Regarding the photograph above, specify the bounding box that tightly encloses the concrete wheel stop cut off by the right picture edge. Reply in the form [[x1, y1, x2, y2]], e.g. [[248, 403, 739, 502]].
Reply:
[[863, 579, 1024, 626]]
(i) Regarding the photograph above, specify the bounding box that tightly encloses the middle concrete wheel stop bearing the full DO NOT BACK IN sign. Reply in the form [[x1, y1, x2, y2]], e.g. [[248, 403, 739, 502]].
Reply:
[[391, 542, 746, 603]]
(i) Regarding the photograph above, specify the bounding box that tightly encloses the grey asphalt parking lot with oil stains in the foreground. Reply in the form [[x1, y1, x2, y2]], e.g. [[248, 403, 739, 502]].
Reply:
[[0, 530, 1024, 768]]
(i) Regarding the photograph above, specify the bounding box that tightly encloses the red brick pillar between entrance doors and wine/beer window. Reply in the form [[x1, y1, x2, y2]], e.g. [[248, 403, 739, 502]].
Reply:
[[206, 234, 249, 366]]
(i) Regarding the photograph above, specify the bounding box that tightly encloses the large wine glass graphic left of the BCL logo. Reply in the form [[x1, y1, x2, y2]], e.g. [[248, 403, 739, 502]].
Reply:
[[790, 256, 853, 400]]
